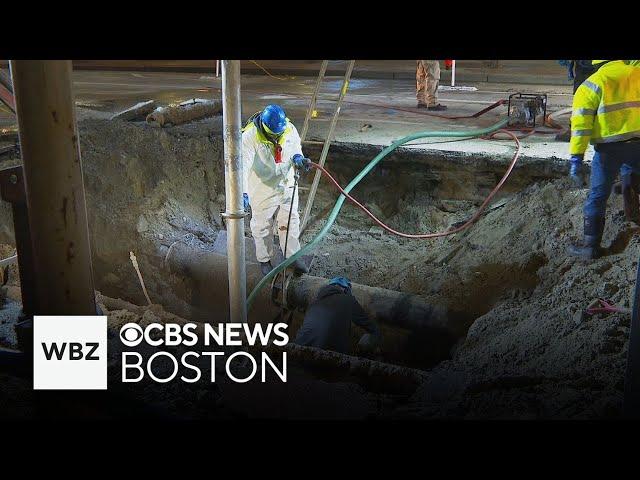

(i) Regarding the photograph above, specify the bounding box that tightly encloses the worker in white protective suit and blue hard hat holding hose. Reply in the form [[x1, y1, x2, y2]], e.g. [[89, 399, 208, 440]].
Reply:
[[242, 105, 311, 275]]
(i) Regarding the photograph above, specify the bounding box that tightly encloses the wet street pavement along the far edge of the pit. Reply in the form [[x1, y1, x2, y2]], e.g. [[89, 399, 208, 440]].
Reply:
[[0, 67, 572, 158]]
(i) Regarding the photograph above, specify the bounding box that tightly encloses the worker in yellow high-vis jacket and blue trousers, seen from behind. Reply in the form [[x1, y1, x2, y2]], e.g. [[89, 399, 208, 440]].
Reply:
[[569, 60, 640, 259]]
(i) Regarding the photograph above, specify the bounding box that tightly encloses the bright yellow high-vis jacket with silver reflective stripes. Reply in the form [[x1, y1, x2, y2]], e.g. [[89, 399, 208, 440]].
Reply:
[[570, 60, 640, 155]]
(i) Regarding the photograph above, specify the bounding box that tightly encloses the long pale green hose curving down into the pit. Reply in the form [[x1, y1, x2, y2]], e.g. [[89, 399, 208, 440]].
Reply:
[[247, 119, 509, 310]]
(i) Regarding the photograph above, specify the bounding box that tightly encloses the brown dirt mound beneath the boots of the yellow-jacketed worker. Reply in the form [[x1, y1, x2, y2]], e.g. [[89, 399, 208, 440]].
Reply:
[[400, 180, 640, 417]]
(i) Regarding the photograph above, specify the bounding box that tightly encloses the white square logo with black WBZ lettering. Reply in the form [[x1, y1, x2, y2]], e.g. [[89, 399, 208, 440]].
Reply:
[[33, 316, 107, 390]]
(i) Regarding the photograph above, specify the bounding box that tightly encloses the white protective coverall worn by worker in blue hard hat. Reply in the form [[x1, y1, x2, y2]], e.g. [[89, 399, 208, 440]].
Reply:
[[242, 119, 302, 262]]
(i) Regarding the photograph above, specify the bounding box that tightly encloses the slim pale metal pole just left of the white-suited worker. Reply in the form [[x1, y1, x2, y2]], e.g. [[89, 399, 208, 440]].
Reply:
[[222, 60, 247, 323]]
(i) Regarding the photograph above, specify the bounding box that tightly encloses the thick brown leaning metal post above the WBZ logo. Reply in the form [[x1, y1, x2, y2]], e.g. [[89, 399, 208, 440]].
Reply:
[[11, 60, 96, 315]]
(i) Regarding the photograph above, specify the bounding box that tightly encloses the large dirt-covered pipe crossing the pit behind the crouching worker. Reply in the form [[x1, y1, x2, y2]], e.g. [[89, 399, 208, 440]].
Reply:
[[165, 243, 456, 338]]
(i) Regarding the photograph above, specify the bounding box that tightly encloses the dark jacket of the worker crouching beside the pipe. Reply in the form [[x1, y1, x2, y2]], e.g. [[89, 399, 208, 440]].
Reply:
[[294, 285, 380, 353]]
